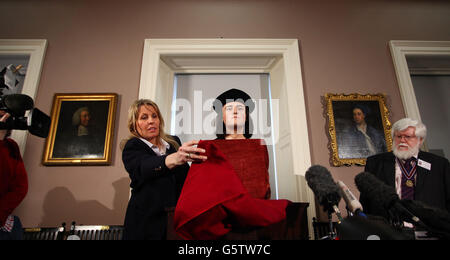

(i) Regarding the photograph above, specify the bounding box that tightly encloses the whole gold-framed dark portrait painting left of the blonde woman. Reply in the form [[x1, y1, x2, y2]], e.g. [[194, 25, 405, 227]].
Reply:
[[42, 93, 117, 166]]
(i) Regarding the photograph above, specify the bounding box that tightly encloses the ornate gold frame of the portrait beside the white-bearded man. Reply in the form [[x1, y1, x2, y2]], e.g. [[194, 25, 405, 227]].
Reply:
[[325, 93, 392, 166]]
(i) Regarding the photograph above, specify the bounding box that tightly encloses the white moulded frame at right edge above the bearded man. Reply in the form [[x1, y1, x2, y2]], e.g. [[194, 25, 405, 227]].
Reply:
[[389, 41, 450, 121]]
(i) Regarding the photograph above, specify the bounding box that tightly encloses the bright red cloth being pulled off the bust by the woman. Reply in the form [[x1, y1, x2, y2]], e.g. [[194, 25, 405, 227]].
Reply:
[[174, 141, 290, 240]]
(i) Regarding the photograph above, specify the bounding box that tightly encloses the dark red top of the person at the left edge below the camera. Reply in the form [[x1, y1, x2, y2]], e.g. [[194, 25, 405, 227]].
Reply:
[[0, 139, 28, 227]]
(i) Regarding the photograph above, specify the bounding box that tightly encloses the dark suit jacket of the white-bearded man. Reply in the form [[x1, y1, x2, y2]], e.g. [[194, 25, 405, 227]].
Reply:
[[360, 151, 450, 216]]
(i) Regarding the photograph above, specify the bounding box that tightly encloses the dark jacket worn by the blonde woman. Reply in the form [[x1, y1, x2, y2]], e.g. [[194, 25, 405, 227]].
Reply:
[[122, 136, 189, 240]]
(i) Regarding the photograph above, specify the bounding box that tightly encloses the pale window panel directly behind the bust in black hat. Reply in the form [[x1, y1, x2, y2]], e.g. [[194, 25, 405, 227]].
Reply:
[[170, 73, 278, 199]]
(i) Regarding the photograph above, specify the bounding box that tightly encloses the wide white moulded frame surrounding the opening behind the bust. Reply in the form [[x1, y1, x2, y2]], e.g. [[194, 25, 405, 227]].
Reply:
[[139, 39, 316, 235]]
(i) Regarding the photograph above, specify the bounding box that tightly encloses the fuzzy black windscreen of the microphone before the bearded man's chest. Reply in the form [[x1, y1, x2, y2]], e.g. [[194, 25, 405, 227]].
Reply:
[[355, 172, 400, 209]]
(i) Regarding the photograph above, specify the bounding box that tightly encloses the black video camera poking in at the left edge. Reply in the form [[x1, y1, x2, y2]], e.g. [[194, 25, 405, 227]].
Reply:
[[0, 94, 51, 138]]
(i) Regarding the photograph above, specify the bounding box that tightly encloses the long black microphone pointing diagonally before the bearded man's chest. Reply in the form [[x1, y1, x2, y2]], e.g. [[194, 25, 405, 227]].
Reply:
[[355, 172, 425, 226]]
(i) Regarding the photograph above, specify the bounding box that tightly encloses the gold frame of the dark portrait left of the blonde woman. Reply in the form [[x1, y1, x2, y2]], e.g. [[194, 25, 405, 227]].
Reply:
[[42, 93, 117, 166]]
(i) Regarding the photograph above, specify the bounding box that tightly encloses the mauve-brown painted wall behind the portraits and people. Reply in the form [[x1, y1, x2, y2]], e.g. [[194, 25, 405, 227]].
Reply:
[[0, 0, 450, 226]]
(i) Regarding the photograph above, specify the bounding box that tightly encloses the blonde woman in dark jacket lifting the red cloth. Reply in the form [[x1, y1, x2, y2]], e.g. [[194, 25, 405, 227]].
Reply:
[[122, 99, 207, 240]]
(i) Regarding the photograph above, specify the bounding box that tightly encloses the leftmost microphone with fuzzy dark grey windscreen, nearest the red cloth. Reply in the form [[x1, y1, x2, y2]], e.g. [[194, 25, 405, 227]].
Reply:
[[305, 165, 342, 222]]
